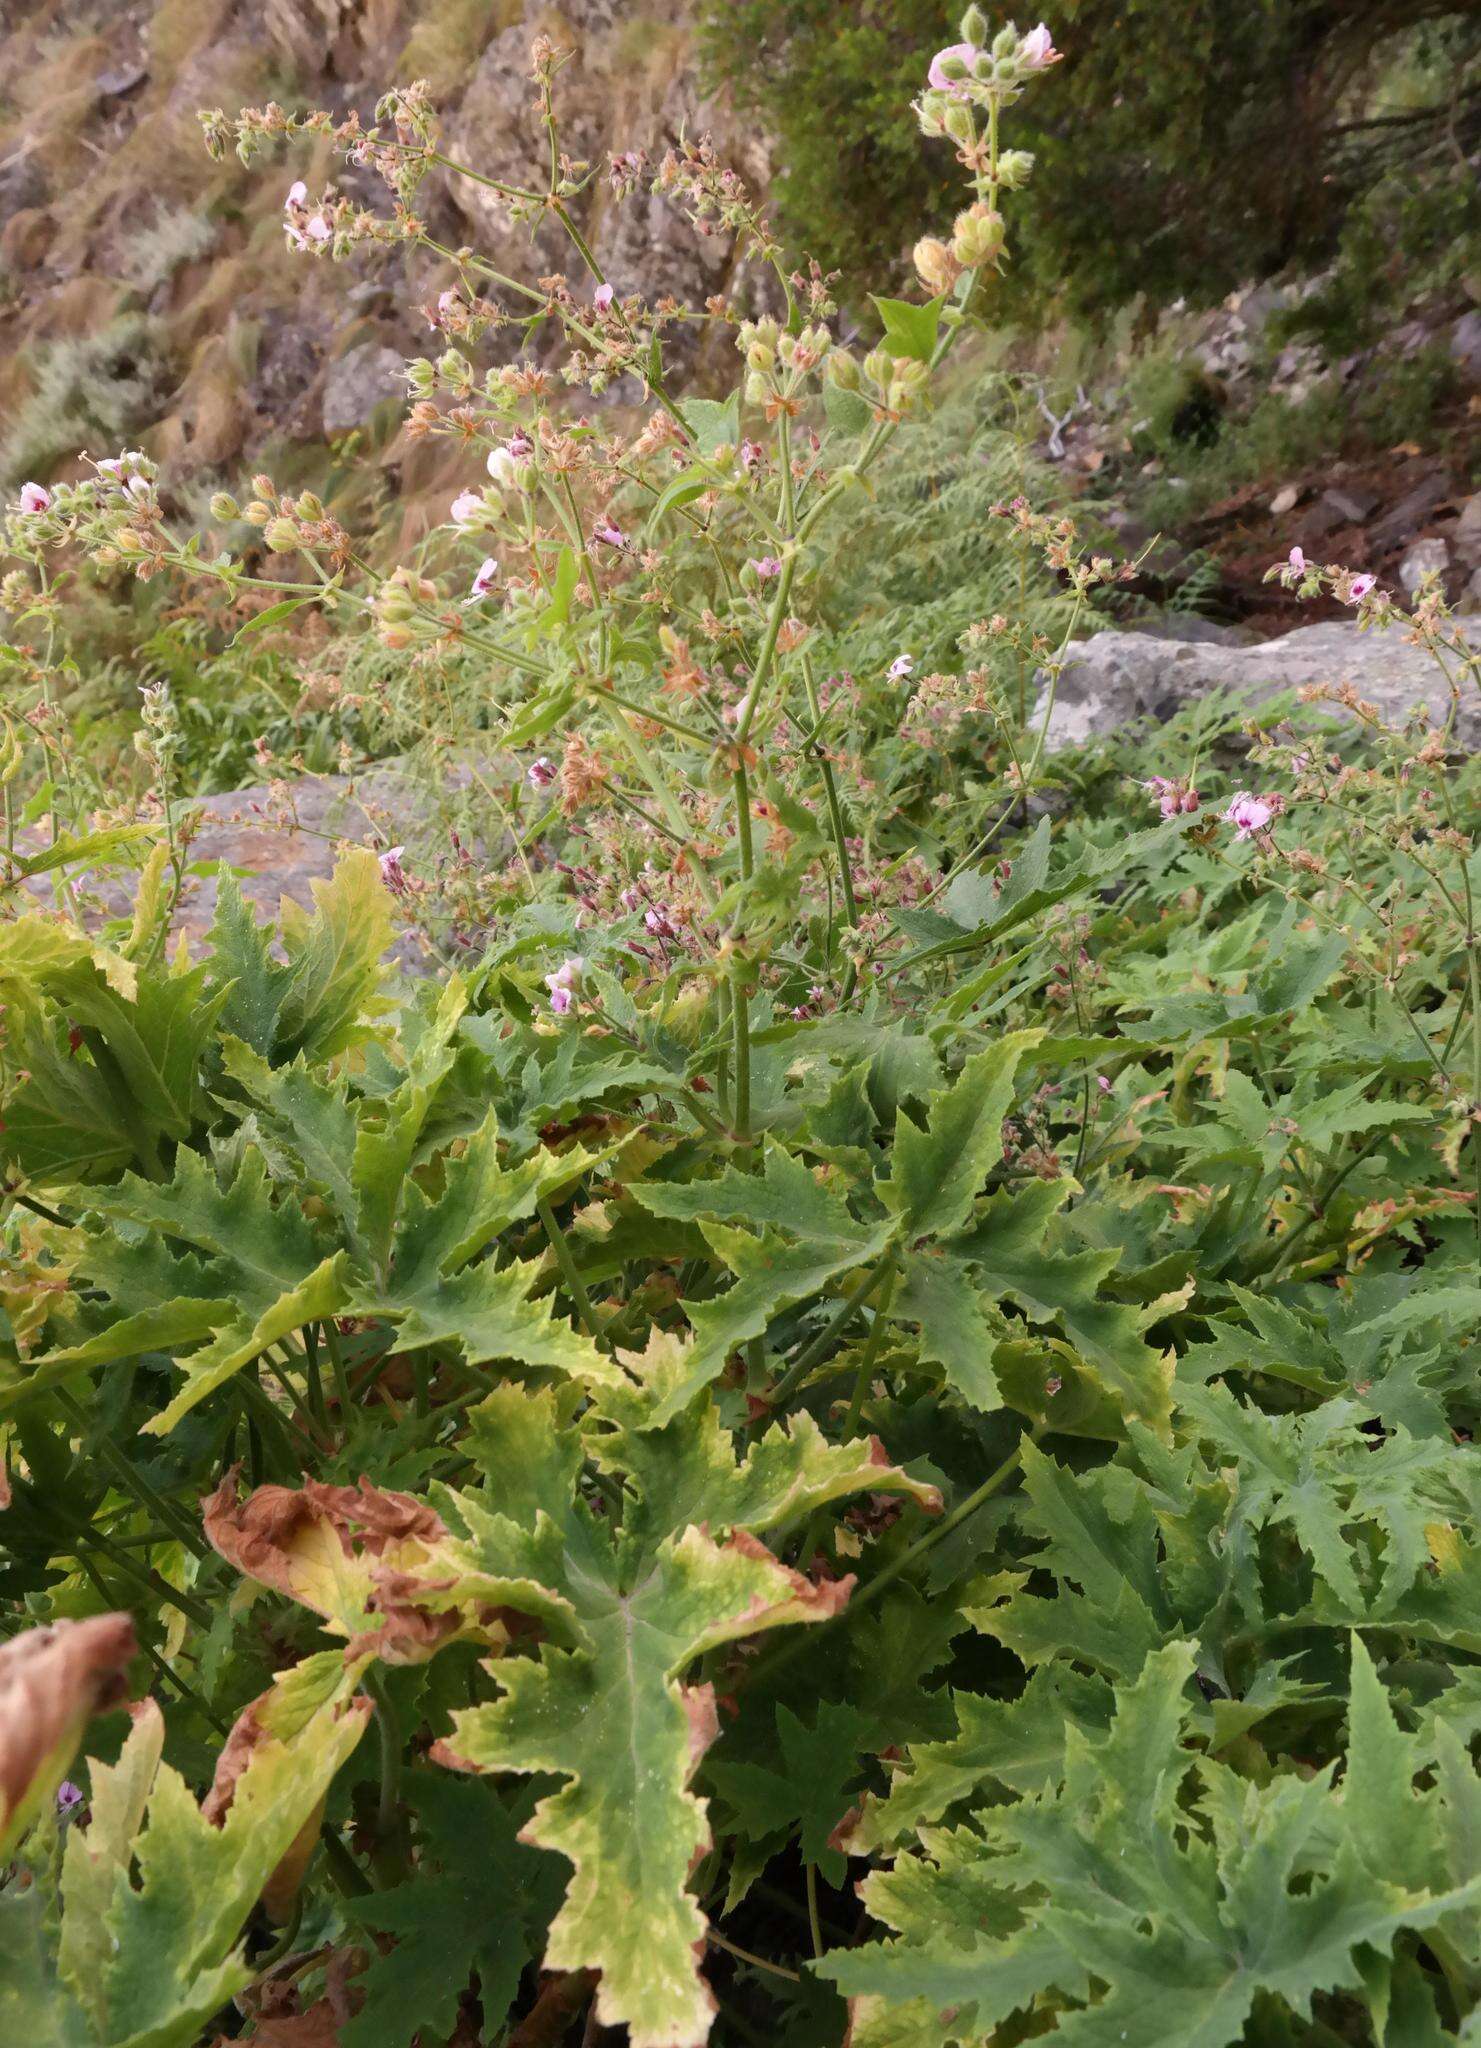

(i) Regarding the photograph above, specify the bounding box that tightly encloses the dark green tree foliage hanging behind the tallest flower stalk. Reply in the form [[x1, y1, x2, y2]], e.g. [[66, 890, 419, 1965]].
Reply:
[[705, 0, 1481, 307]]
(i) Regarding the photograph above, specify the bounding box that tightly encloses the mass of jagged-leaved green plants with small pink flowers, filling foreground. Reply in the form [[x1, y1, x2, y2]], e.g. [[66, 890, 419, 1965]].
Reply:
[[0, 8, 1481, 2048]]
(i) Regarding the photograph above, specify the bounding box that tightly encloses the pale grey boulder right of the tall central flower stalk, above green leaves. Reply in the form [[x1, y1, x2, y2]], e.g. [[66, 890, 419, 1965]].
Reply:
[[1034, 621, 1481, 754]]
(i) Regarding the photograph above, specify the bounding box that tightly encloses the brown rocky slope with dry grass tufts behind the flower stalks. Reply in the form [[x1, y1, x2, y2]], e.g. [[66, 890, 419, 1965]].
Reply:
[[0, 0, 766, 522]]
